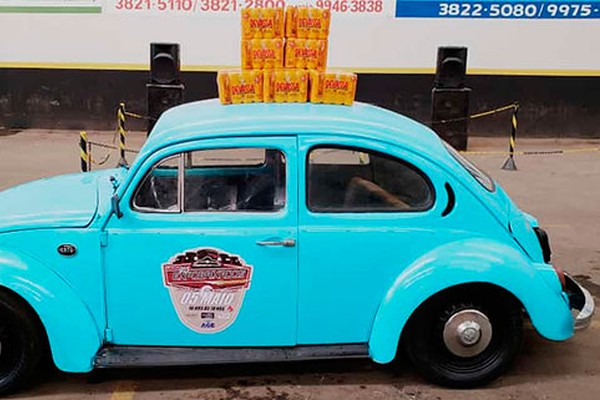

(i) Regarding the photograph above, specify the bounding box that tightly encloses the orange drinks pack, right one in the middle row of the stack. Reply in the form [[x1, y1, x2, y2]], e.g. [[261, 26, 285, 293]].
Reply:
[[285, 39, 327, 71]]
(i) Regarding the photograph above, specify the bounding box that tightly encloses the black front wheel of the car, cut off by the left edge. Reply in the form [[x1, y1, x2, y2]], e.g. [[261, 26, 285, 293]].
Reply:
[[0, 293, 44, 395]]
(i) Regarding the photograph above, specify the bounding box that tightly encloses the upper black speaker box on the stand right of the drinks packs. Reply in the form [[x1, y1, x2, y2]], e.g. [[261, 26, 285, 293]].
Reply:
[[434, 47, 467, 88]]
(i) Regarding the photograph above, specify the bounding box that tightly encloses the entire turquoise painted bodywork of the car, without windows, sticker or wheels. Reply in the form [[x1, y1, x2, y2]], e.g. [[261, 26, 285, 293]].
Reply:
[[0, 100, 584, 372]]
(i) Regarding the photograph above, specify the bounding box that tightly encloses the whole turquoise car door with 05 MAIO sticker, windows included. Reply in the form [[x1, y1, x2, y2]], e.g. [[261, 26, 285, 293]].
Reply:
[[104, 137, 297, 346]]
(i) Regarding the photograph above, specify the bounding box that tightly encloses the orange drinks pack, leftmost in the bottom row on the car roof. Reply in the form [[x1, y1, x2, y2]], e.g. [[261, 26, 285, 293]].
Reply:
[[217, 70, 264, 104]]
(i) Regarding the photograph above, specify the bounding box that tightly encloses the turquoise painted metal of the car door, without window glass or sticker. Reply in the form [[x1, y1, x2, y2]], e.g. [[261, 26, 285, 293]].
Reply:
[[104, 136, 298, 347]]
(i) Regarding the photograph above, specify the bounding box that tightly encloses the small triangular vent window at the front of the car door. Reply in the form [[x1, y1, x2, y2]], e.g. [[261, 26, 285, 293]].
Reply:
[[133, 155, 181, 212]]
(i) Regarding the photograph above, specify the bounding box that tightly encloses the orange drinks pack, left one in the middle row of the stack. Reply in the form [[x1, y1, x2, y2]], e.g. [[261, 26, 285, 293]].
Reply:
[[242, 39, 283, 69]]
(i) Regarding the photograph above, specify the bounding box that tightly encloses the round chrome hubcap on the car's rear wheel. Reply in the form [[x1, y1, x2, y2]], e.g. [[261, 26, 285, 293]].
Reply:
[[443, 309, 492, 357]]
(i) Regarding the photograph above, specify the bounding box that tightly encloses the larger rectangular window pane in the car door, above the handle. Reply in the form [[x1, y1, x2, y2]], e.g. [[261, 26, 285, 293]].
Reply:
[[184, 148, 285, 212]]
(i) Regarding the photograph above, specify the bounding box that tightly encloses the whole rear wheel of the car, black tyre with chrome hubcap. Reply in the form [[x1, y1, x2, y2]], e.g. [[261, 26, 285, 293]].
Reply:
[[403, 287, 523, 388]]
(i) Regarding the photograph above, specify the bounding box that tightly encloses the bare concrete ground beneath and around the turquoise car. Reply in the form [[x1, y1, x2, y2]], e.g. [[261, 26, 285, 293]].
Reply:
[[0, 131, 600, 400]]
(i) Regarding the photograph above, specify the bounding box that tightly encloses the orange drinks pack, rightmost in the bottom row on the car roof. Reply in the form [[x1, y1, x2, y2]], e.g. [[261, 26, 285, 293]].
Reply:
[[310, 71, 358, 106]]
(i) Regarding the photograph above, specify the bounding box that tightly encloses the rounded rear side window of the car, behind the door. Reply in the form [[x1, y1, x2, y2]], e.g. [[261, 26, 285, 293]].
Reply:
[[307, 146, 434, 212]]
